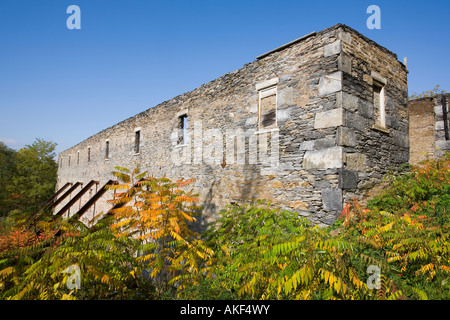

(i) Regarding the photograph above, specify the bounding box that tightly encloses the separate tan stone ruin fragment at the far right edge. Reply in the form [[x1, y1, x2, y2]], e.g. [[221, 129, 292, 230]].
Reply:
[[408, 93, 450, 164]]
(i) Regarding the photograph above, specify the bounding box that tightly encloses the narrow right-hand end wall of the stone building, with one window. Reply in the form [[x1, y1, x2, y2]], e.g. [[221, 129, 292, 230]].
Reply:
[[337, 26, 409, 202]]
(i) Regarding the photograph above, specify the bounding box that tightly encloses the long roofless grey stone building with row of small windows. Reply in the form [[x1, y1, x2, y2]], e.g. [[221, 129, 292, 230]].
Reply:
[[54, 24, 409, 225]]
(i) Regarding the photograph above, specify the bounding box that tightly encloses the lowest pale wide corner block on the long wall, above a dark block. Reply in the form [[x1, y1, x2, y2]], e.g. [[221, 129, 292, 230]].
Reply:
[[303, 147, 342, 169]]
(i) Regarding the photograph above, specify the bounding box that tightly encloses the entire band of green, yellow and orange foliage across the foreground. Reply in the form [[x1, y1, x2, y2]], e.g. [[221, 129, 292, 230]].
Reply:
[[0, 155, 450, 300]]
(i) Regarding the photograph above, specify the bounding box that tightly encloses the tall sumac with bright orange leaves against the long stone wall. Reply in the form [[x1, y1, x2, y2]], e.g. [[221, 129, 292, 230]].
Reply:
[[108, 167, 213, 294]]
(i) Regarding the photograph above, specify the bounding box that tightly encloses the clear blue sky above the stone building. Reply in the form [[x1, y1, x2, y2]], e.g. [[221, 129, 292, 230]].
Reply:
[[0, 0, 450, 152]]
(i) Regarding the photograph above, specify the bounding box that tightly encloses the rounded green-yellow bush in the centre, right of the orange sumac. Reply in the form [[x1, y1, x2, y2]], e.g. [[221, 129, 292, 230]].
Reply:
[[195, 202, 392, 299]]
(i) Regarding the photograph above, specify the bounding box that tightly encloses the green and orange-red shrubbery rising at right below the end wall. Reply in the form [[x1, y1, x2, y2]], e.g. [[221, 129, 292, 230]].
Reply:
[[343, 155, 450, 299]]
